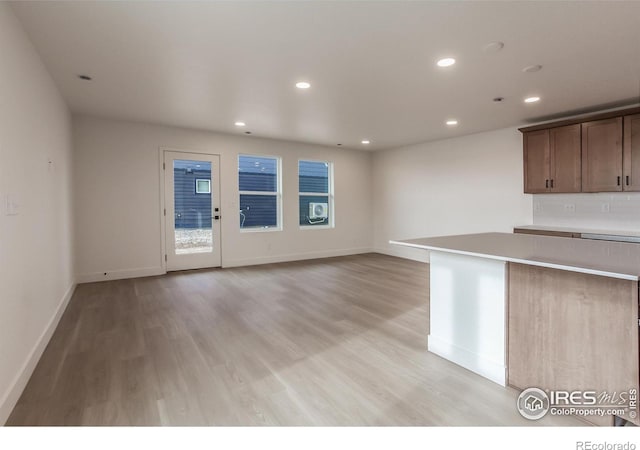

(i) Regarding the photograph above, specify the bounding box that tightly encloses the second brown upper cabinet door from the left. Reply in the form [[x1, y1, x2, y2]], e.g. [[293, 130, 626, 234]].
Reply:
[[549, 124, 582, 192]]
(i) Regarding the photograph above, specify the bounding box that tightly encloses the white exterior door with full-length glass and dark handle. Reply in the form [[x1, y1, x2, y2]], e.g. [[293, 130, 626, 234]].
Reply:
[[163, 151, 220, 271]]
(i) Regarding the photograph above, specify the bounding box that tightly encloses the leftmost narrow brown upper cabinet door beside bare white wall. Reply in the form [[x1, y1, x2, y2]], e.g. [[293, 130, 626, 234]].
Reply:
[[522, 130, 550, 194]]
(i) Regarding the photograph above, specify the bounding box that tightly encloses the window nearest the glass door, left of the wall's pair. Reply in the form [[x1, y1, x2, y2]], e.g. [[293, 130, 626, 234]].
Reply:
[[238, 155, 281, 230]]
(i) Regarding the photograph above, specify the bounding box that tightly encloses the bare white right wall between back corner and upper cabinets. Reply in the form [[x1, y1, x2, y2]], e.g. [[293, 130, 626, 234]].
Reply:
[[373, 128, 532, 261]]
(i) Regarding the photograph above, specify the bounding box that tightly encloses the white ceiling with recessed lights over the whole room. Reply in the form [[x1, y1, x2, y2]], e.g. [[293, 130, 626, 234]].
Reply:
[[12, 1, 640, 150]]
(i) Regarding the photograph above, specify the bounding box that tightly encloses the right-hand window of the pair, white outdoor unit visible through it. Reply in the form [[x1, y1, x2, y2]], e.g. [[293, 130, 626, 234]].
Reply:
[[298, 161, 333, 227]]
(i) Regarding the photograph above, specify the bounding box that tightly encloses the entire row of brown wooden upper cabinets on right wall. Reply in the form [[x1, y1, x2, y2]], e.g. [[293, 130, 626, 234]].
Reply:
[[520, 108, 640, 194]]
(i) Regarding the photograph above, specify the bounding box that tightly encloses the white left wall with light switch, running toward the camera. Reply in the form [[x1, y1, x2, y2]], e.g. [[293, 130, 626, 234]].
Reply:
[[0, 2, 74, 424]]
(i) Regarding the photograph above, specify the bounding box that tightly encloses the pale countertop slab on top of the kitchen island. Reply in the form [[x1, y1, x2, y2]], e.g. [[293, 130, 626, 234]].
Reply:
[[389, 233, 640, 281]]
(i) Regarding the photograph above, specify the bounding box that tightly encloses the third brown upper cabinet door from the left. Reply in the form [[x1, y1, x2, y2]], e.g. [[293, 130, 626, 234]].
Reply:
[[582, 117, 622, 192]]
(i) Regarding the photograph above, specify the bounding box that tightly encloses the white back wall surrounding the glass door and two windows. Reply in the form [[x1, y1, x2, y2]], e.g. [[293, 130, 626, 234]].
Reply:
[[74, 116, 373, 281]]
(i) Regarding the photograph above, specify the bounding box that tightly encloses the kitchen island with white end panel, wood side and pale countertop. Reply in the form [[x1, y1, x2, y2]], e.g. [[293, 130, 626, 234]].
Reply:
[[391, 233, 640, 424]]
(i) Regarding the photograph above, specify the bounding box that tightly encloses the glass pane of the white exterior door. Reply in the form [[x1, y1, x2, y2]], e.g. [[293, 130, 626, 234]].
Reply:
[[173, 160, 213, 255]]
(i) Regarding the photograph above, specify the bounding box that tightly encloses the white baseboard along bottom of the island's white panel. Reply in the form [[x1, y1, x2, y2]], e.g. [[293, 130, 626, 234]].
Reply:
[[427, 334, 507, 386]]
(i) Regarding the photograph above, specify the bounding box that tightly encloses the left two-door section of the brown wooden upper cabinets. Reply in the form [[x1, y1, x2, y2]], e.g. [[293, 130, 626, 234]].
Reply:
[[523, 124, 581, 194]]
